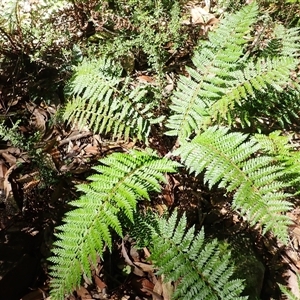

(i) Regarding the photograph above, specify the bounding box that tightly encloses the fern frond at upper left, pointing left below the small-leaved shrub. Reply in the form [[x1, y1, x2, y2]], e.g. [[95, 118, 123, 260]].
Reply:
[[64, 59, 164, 141]]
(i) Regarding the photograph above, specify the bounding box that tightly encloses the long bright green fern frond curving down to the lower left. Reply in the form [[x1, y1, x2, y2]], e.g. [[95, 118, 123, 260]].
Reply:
[[50, 151, 179, 300]]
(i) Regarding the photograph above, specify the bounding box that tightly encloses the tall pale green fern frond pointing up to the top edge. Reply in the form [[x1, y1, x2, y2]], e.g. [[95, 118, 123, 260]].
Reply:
[[166, 3, 257, 138]]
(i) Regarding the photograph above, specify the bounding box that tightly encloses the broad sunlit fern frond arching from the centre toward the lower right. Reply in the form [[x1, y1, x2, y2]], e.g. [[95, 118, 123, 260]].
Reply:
[[174, 127, 292, 242]]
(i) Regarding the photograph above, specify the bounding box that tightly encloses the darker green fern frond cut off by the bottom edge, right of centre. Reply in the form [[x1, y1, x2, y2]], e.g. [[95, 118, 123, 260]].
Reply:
[[150, 212, 247, 300]]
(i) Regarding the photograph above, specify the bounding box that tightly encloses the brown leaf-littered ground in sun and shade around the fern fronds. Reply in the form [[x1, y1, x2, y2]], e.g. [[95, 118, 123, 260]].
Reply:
[[0, 1, 300, 300]]
